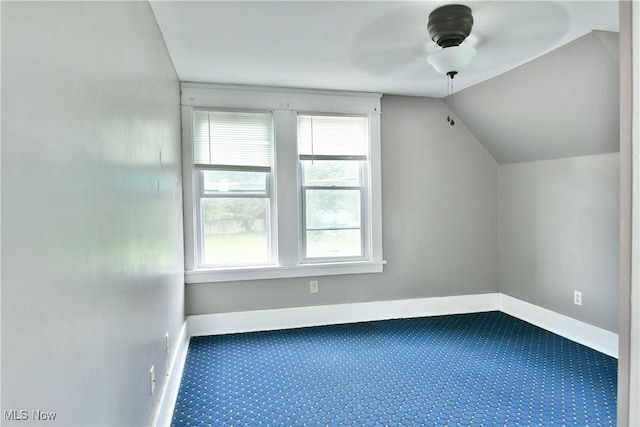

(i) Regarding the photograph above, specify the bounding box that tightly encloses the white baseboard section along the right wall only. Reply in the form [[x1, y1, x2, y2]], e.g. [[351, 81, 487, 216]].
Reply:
[[499, 293, 618, 358]]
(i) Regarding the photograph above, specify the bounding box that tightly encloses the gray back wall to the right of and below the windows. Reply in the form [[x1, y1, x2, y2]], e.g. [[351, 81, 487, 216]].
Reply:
[[186, 96, 498, 314]]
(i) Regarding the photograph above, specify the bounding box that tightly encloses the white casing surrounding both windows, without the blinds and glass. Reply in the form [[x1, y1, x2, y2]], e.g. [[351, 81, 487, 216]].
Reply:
[[181, 83, 385, 283]]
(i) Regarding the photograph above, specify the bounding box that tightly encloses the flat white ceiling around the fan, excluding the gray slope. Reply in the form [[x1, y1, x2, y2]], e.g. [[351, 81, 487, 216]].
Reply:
[[151, 0, 618, 98]]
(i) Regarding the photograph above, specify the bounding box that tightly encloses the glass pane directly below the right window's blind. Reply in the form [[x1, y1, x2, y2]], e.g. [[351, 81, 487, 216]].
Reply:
[[301, 160, 362, 187]]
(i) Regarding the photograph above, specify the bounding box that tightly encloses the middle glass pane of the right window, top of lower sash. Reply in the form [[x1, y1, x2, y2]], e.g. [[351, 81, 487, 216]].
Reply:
[[305, 190, 361, 230]]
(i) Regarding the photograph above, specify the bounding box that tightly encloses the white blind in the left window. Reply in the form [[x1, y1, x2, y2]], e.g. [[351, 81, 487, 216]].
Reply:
[[193, 110, 273, 172]]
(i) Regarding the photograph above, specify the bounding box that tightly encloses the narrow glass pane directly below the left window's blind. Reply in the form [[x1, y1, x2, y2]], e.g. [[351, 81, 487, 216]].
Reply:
[[201, 171, 269, 194]]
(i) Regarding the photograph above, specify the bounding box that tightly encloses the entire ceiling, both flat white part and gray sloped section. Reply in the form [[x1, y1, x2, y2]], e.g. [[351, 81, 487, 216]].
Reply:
[[151, 0, 618, 163]]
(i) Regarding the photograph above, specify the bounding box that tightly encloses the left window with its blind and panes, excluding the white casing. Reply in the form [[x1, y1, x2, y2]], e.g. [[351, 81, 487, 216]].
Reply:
[[193, 110, 273, 267]]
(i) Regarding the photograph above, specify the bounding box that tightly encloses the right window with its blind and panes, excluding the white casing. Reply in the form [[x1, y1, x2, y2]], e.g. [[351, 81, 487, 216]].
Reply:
[[298, 115, 369, 261]]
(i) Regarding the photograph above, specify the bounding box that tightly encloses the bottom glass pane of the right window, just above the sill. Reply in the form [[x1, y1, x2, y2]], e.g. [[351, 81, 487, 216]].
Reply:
[[307, 230, 362, 258]]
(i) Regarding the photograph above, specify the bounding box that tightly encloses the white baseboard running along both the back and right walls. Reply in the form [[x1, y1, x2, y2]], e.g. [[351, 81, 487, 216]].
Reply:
[[187, 293, 618, 358]]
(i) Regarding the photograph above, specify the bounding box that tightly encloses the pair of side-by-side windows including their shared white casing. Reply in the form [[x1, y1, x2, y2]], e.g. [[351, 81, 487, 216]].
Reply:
[[182, 83, 384, 283]]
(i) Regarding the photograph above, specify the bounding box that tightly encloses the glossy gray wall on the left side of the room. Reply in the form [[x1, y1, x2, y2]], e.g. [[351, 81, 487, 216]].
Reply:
[[2, 2, 184, 426]]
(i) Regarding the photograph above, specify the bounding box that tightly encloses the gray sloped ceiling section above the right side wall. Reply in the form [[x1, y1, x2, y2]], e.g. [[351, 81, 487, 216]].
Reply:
[[450, 31, 619, 163]]
